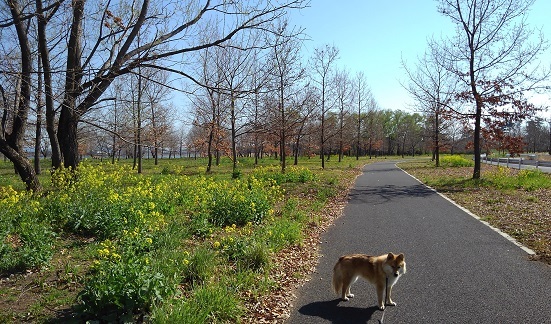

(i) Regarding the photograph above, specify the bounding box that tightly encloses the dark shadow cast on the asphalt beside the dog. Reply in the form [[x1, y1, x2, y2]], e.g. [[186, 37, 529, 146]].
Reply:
[[298, 298, 379, 324]]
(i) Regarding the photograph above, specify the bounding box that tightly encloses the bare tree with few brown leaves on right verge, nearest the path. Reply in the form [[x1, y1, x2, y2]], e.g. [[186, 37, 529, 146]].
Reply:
[[431, 0, 546, 179]]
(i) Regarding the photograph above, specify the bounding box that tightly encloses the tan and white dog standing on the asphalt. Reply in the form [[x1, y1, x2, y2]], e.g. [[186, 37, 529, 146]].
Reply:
[[332, 253, 406, 310]]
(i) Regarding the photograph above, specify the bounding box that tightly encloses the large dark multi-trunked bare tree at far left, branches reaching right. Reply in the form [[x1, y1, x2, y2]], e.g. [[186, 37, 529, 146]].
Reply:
[[0, 0, 304, 190]]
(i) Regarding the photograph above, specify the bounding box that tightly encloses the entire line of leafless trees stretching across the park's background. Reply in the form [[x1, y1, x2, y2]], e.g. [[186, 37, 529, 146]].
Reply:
[[0, 0, 548, 190]]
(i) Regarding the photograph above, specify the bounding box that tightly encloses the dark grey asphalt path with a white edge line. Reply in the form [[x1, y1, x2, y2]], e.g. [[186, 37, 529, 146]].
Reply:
[[286, 162, 551, 324]]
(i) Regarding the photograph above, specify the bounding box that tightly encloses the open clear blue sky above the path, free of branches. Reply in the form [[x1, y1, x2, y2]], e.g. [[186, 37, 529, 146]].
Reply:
[[291, 0, 551, 116]]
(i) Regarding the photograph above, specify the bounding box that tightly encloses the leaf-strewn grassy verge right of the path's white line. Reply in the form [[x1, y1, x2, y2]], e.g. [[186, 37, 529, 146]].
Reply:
[[399, 157, 551, 264]]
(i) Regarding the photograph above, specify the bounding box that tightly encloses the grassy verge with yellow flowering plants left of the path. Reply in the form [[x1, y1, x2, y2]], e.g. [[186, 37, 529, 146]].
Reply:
[[0, 158, 368, 323]]
